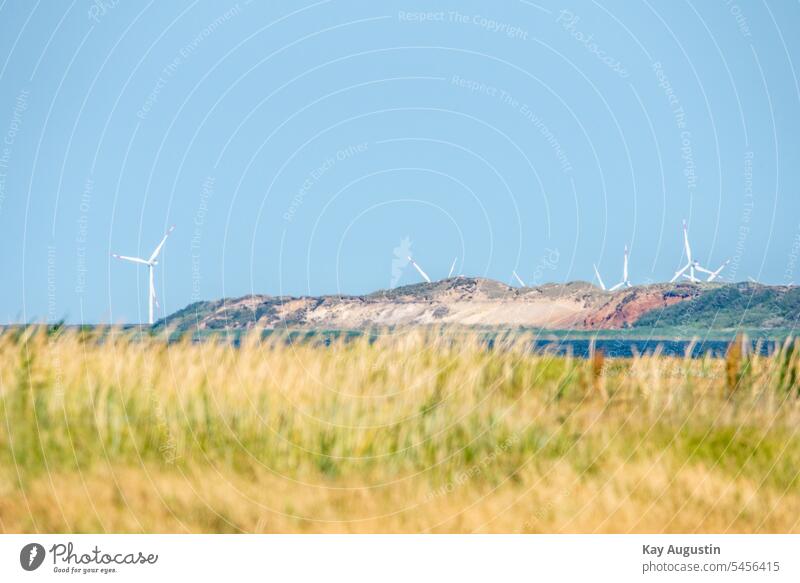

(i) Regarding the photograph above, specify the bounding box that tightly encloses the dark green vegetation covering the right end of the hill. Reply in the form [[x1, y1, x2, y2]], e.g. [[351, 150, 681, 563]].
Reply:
[[634, 283, 800, 330]]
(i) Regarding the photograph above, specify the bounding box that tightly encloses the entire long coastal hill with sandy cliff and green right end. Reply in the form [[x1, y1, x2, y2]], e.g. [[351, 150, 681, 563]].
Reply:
[[156, 277, 800, 331]]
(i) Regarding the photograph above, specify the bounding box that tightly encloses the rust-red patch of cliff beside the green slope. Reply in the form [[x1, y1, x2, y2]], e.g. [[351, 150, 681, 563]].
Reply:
[[583, 285, 700, 330]]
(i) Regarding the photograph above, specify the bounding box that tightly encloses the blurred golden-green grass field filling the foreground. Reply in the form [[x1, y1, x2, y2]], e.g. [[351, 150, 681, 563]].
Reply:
[[0, 327, 800, 533]]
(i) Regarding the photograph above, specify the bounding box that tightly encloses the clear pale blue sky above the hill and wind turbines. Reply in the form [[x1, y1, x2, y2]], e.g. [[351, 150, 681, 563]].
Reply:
[[0, 0, 800, 323]]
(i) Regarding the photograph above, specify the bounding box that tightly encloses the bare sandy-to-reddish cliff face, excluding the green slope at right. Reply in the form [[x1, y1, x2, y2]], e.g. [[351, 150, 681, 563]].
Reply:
[[159, 277, 715, 330]]
